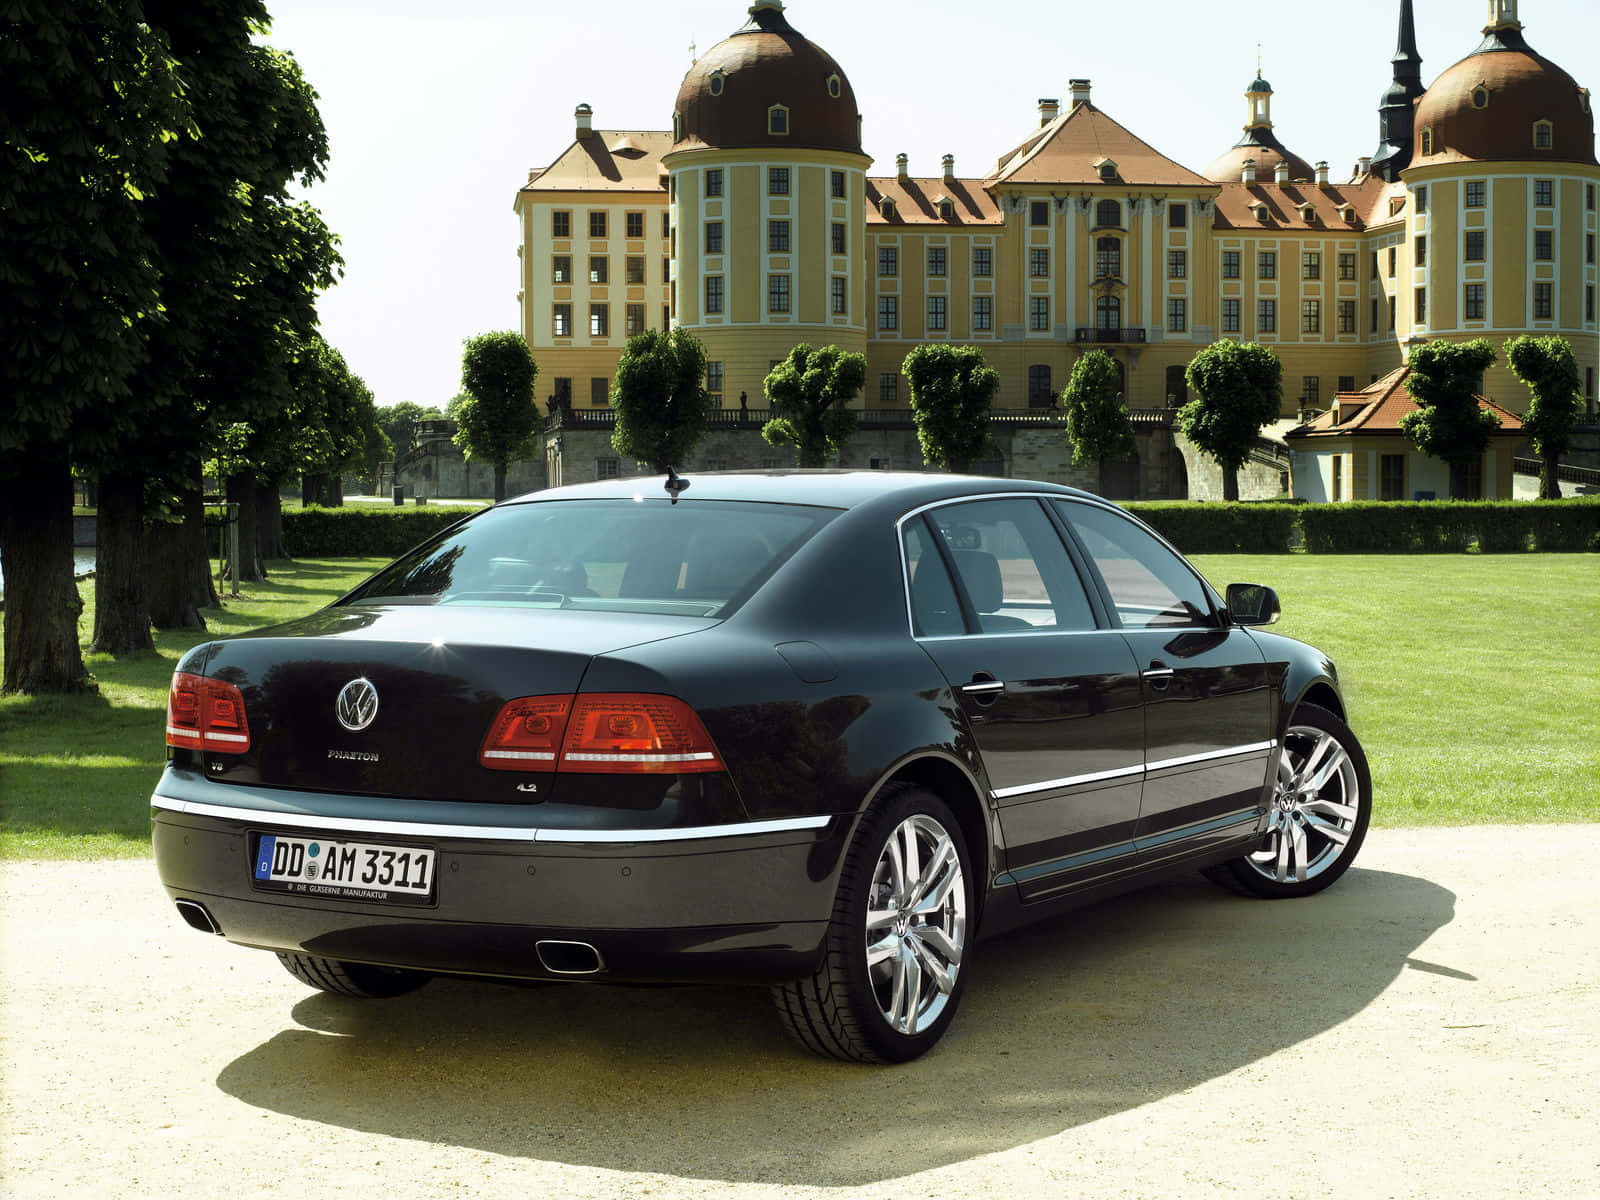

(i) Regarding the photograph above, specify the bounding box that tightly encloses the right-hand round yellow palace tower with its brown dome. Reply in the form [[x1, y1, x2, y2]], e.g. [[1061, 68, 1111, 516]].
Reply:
[[1400, 0, 1600, 413]]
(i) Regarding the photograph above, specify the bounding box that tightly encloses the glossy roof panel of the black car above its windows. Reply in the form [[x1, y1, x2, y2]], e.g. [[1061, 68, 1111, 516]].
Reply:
[[506, 469, 1099, 509]]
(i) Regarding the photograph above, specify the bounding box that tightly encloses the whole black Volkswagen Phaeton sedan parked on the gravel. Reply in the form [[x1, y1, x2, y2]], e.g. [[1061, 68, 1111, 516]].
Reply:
[[150, 472, 1371, 1062]]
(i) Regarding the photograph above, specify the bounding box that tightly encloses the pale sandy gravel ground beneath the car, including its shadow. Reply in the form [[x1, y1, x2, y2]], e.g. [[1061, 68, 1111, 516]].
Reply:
[[0, 826, 1600, 1200]]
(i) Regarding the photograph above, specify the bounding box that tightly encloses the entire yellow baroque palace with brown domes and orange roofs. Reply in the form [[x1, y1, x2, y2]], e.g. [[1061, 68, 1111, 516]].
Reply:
[[489, 0, 1600, 498]]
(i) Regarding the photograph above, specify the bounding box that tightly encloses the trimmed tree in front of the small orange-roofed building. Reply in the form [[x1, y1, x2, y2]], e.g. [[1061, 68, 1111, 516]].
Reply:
[[1400, 338, 1499, 499]]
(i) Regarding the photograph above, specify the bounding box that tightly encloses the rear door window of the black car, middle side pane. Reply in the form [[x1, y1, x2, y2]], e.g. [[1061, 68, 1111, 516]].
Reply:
[[928, 499, 1094, 634]]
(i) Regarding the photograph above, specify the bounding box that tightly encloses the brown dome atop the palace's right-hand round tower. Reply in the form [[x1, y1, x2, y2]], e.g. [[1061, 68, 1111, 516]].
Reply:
[[1411, 29, 1595, 166]]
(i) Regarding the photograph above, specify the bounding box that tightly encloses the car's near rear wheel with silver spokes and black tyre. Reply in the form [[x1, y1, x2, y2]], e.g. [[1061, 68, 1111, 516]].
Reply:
[[773, 784, 976, 1062]]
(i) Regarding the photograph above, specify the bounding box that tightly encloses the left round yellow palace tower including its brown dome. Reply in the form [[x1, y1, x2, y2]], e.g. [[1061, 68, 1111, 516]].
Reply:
[[662, 0, 872, 406]]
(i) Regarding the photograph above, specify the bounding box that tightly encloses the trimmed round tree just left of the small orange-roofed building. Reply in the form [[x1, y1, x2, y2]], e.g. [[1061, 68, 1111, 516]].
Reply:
[[1178, 341, 1283, 501]]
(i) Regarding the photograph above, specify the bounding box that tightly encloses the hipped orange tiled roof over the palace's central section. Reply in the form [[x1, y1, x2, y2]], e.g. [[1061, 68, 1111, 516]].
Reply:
[[989, 101, 1210, 187]]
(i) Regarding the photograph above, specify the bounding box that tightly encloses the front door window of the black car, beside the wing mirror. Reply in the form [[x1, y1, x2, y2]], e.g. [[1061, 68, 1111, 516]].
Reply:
[[1054, 501, 1213, 629]]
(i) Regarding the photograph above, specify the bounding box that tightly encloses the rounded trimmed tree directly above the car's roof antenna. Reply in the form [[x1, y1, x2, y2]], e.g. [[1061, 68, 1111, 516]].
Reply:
[[611, 330, 710, 474]]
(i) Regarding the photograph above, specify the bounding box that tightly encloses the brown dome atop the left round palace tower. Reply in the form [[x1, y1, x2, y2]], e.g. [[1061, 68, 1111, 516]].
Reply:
[[672, 0, 861, 154]]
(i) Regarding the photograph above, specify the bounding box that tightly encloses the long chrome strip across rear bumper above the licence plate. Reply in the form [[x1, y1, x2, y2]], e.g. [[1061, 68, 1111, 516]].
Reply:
[[150, 794, 832, 845]]
